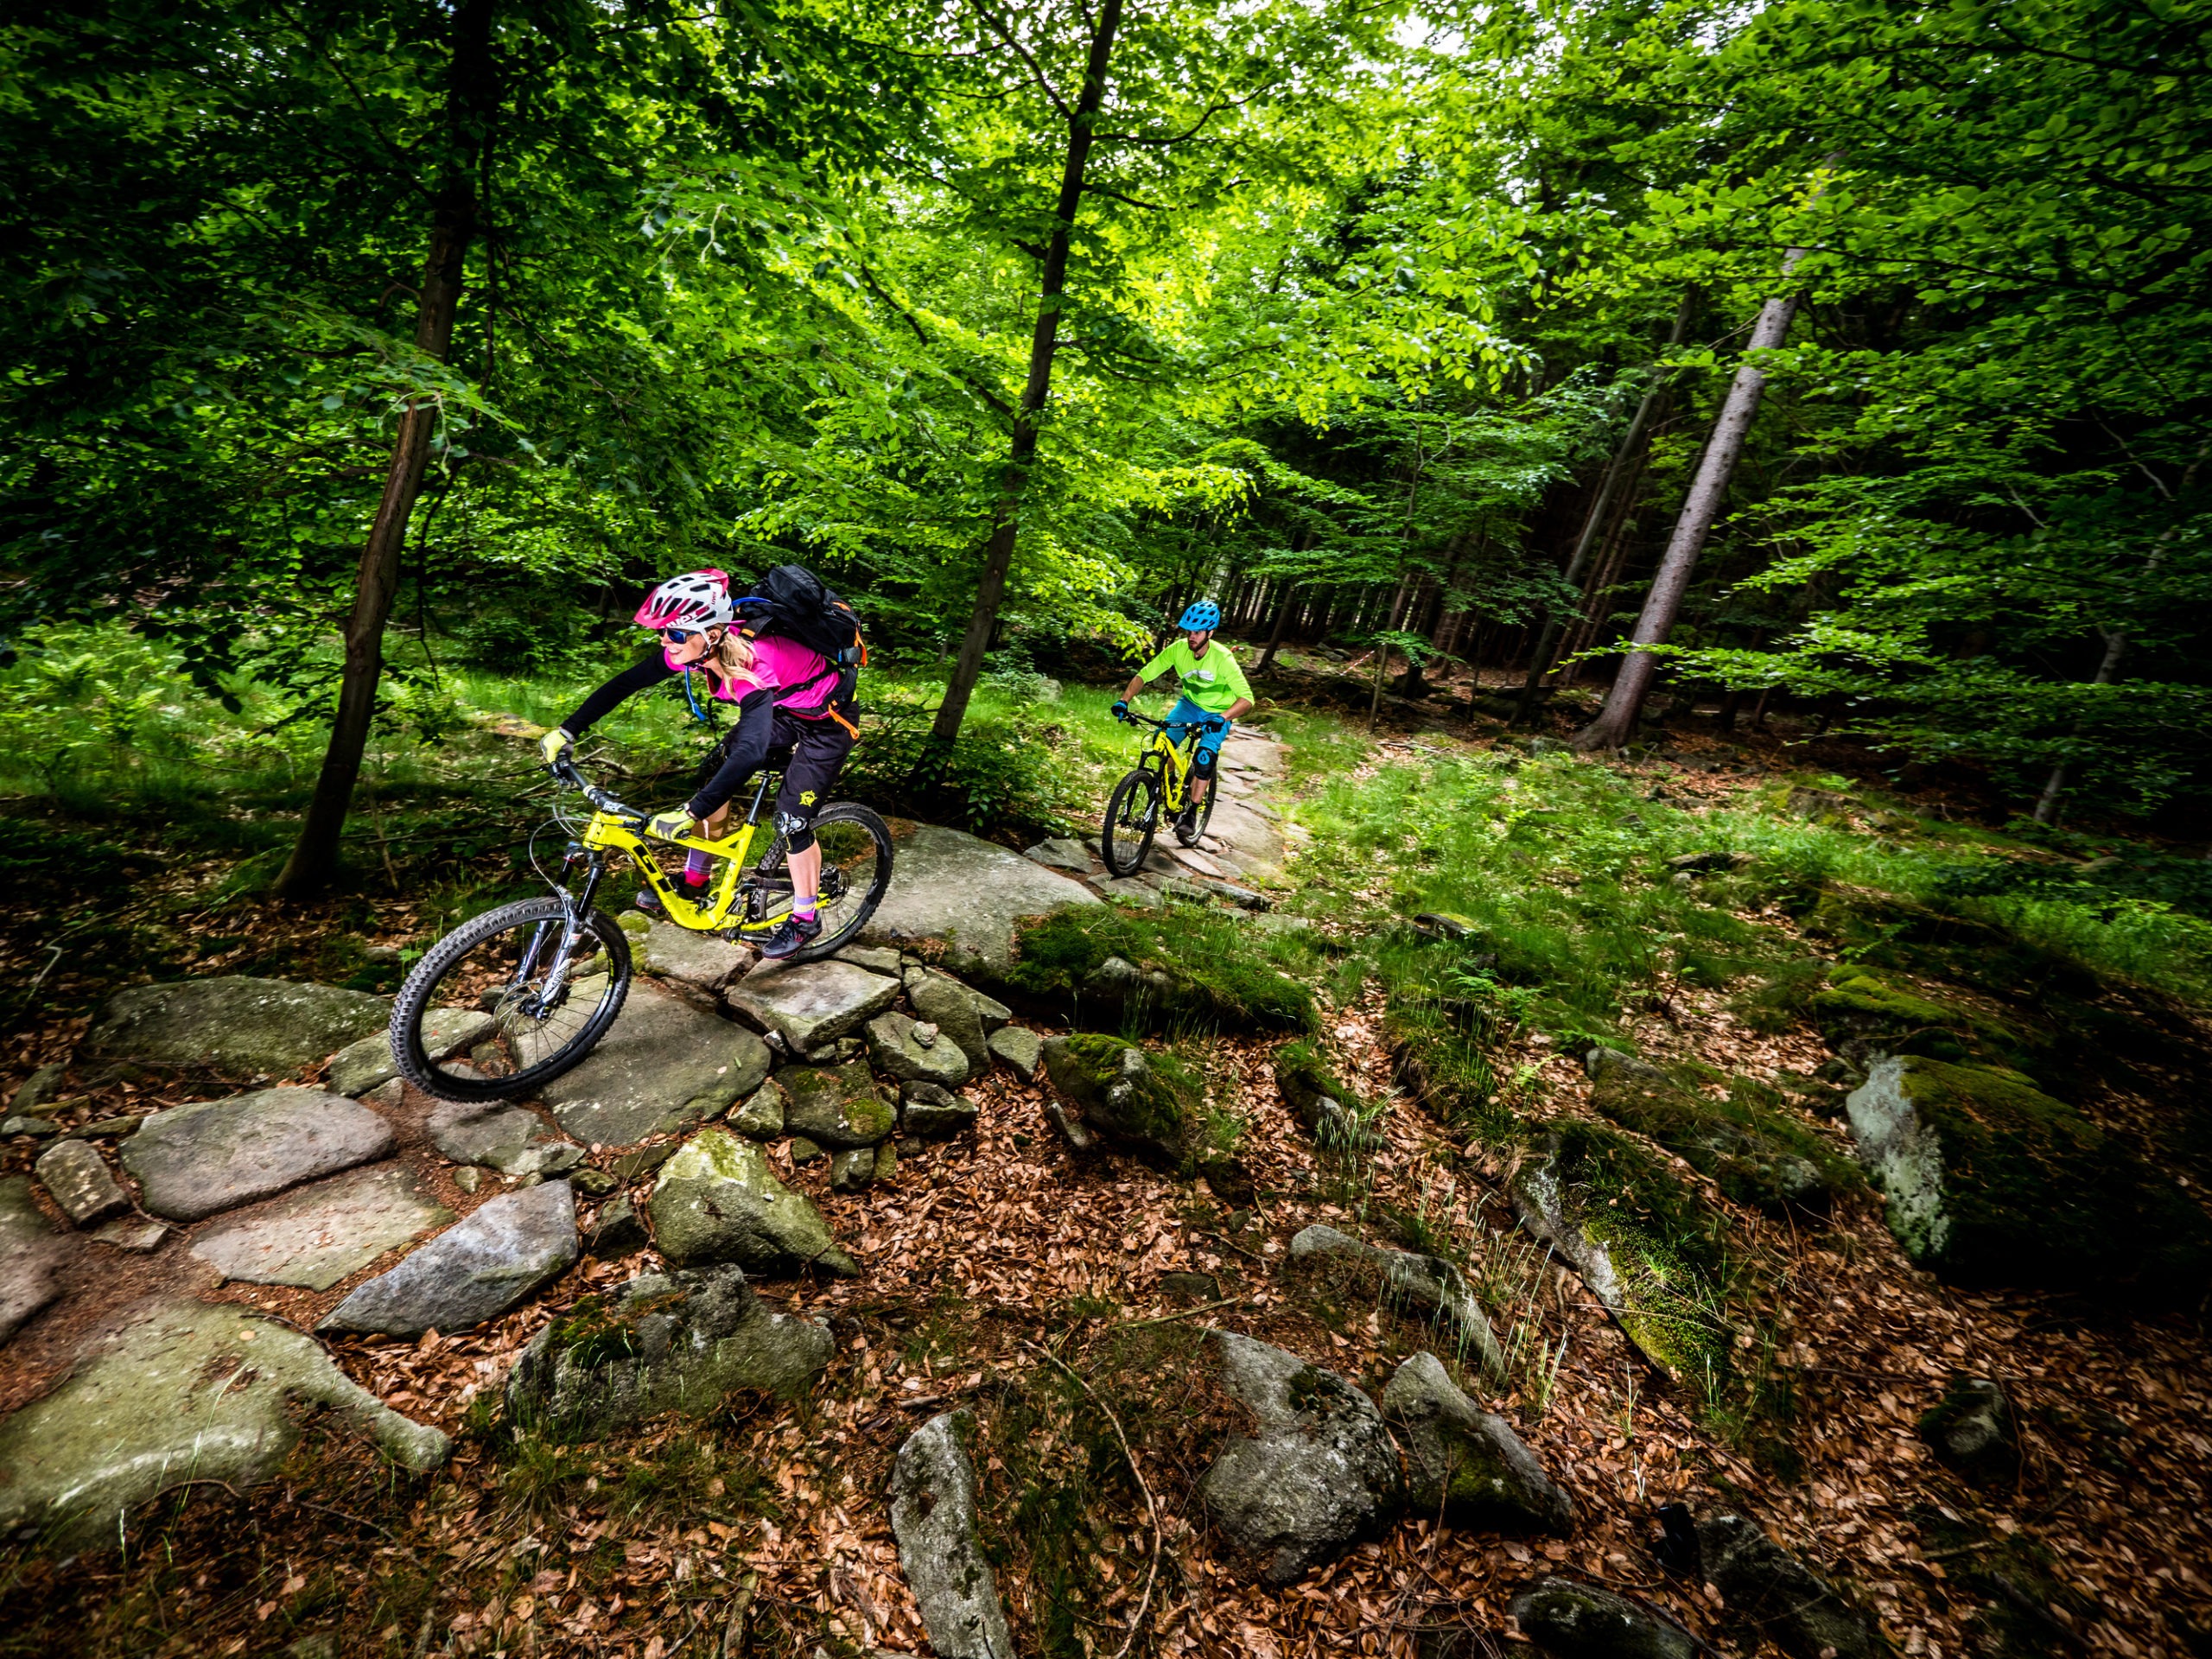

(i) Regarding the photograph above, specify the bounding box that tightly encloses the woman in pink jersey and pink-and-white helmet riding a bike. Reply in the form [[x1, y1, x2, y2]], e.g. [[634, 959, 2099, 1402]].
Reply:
[[537, 570, 858, 956]]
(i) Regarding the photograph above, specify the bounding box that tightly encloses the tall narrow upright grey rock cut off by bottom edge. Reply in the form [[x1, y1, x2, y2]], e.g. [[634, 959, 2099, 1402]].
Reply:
[[892, 1411, 1013, 1659]]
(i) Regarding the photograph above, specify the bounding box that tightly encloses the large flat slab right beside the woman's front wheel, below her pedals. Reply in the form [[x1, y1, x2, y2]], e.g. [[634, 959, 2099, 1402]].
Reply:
[[544, 984, 770, 1146]]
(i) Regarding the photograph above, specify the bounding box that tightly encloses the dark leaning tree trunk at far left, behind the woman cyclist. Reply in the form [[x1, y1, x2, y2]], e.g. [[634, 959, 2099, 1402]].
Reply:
[[276, 0, 498, 898]]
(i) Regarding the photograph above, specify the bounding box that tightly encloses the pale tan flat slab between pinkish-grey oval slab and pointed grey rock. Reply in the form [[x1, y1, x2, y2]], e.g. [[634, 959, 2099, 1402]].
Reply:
[[193, 1164, 454, 1289]]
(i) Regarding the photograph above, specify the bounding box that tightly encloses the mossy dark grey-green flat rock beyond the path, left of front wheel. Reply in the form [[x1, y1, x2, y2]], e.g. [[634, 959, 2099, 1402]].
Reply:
[[82, 978, 391, 1082]]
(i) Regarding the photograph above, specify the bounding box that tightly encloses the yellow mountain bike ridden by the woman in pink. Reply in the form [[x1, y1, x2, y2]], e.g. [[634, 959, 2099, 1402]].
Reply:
[[391, 761, 892, 1099]]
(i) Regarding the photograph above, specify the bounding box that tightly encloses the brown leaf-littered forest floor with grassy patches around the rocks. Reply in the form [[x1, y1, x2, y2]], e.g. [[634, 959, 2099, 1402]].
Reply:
[[0, 659, 2212, 1659]]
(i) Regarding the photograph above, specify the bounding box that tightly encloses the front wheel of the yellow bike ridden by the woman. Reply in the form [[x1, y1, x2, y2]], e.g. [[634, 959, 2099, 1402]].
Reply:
[[391, 898, 632, 1099]]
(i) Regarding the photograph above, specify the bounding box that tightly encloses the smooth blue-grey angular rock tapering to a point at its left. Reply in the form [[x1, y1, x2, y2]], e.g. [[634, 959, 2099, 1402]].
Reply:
[[316, 1181, 577, 1336]]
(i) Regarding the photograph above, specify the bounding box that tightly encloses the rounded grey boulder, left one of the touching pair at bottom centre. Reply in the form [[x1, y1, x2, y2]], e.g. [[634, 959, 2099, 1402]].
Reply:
[[1199, 1332, 1405, 1588]]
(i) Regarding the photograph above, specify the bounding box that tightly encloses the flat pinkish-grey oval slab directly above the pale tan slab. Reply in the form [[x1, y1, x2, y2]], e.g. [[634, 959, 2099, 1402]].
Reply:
[[124, 1089, 394, 1221]]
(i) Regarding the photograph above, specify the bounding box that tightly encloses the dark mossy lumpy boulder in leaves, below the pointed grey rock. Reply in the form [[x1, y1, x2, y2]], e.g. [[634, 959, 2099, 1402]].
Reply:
[[506, 1265, 836, 1440]]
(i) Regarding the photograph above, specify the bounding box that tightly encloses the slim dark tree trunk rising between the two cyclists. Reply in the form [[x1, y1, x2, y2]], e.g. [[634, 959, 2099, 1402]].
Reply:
[[929, 0, 1122, 743]]
